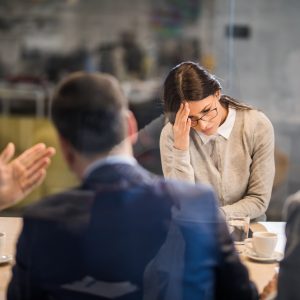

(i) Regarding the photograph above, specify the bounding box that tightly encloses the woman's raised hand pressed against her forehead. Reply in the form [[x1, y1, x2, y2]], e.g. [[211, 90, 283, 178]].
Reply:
[[173, 102, 191, 150]]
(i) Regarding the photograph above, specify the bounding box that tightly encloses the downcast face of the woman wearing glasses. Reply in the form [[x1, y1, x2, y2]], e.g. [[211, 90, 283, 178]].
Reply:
[[187, 91, 226, 135]]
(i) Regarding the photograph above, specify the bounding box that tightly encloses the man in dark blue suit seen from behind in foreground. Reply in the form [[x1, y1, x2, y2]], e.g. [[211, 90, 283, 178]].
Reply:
[[7, 72, 257, 300]]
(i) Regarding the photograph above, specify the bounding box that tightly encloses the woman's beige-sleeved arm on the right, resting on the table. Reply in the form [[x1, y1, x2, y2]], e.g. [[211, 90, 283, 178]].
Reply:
[[221, 115, 275, 219]]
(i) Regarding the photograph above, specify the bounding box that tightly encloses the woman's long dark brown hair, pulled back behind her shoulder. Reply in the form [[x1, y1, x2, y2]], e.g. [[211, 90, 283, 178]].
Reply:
[[163, 62, 252, 123]]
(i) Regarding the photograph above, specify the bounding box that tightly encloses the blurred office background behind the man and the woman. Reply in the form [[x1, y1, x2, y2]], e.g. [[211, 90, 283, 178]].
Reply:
[[0, 0, 300, 220]]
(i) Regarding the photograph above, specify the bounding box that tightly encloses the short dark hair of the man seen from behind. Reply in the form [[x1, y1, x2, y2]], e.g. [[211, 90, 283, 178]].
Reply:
[[51, 72, 127, 155]]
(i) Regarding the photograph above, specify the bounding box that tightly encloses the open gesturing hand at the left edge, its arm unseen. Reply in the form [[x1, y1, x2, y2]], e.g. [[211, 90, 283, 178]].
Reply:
[[0, 143, 55, 210]]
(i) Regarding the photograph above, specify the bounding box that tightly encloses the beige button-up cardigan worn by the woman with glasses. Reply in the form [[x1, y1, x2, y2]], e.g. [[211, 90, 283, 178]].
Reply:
[[160, 110, 275, 219]]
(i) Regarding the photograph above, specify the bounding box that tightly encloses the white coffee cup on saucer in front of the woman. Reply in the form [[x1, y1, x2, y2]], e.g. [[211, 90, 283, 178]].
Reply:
[[251, 231, 278, 258]]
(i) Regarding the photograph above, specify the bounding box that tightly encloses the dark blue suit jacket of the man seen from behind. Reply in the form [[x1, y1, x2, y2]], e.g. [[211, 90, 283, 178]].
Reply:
[[8, 163, 257, 300]]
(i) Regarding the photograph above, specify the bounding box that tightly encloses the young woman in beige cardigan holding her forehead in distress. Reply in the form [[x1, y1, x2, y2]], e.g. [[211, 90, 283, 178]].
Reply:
[[160, 62, 275, 219]]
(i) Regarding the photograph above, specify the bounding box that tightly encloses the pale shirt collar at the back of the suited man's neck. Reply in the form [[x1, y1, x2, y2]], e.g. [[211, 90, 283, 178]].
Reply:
[[83, 155, 137, 178]]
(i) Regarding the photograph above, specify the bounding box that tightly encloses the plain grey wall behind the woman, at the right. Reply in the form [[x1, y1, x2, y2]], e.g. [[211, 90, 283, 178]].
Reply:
[[213, 0, 300, 215]]
